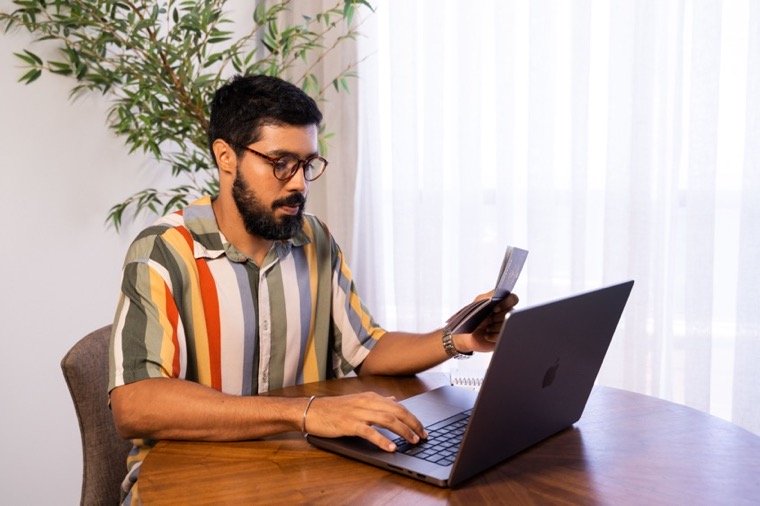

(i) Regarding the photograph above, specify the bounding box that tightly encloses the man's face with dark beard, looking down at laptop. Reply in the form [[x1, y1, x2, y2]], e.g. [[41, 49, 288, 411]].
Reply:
[[232, 125, 317, 240]]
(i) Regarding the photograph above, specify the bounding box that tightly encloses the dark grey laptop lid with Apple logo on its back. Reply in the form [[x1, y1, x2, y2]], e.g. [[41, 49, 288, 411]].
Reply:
[[449, 281, 633, 486]]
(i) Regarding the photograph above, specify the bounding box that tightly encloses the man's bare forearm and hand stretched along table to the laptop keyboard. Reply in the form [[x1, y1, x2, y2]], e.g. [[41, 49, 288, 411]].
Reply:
[[111, 378, 425, 451]]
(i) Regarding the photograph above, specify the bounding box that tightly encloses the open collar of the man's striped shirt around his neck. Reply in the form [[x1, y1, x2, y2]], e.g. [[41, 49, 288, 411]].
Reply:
[[182, 195, 311, 263]]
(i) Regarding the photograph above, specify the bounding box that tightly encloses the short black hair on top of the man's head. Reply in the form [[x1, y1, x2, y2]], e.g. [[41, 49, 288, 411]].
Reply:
[[208, 75, 322, 163]]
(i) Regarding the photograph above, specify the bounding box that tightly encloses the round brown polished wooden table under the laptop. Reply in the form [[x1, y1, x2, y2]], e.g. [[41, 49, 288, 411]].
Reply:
[[139, 375, 760, 506]]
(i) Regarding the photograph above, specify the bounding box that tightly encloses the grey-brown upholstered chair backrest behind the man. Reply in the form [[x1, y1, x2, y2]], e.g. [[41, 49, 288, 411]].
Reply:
[[61, 325, 132, 505]]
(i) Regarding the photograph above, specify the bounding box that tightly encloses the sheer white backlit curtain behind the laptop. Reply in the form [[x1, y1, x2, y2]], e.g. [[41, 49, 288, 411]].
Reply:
[[351, 0, 760, 433]]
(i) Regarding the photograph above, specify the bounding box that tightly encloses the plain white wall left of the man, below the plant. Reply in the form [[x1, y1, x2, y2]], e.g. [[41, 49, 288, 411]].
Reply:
[[0, 28, 172, 504]]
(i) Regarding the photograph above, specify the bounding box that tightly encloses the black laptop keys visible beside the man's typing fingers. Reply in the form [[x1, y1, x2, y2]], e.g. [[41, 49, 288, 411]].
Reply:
[[393, 409, 472, 466]]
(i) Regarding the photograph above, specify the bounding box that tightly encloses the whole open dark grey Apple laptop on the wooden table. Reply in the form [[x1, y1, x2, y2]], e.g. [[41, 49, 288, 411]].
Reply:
[[308, 281, 633, 487]]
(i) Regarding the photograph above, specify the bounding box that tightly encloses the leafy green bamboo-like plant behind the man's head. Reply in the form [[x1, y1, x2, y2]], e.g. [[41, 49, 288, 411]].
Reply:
[[0, 0, 372, 229]]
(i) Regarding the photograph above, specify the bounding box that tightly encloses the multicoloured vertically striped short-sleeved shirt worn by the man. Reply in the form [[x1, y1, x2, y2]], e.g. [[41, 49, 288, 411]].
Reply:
[[108, 197, 385, 500]]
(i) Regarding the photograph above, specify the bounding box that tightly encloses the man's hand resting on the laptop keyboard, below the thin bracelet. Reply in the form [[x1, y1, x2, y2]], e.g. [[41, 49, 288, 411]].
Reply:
[[304, 392, 427, 452]]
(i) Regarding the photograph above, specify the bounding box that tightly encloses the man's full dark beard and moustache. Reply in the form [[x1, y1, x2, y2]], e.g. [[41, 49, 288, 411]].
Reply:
[[232, 171, 306, 241]]
